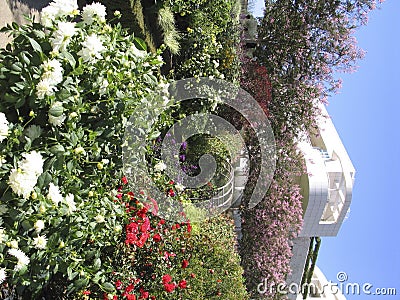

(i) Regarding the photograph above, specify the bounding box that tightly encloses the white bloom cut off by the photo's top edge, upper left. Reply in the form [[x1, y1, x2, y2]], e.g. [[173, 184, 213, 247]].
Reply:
[[41, 0, 78, 27]]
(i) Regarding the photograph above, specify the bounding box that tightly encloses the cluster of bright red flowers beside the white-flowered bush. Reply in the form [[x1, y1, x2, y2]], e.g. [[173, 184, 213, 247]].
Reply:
[[111, 180, 192, 300]]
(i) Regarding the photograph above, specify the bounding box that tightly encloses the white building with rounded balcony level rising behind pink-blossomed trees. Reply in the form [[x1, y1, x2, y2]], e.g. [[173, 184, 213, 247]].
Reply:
[[286, 104, 355, 299]]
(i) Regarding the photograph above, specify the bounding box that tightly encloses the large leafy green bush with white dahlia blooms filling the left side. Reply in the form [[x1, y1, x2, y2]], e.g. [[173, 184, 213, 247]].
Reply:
[[0, 2, 164, 299]]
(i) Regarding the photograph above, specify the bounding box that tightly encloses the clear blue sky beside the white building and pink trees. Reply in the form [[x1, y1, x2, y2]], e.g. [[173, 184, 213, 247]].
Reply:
[[256, 0, 400, 300]]
